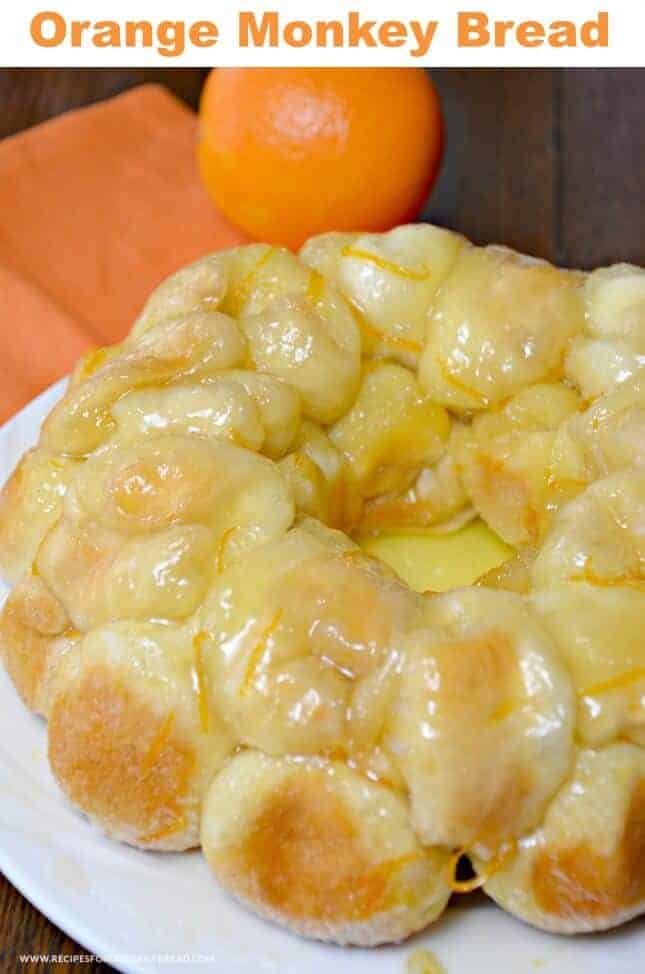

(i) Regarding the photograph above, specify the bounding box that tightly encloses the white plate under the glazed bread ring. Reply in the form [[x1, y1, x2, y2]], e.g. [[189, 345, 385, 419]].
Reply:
[[0, 383, 645, 974]]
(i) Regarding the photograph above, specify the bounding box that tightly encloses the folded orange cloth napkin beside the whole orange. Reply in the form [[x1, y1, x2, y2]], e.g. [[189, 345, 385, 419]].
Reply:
[[0, 85, 244, 422]]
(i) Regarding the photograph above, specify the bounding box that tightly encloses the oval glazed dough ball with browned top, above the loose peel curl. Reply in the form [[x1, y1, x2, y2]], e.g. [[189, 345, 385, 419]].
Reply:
[[386, 588, 574, 850]]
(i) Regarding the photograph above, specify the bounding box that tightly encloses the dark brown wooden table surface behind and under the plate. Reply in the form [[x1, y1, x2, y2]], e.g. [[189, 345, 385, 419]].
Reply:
[[0, 68, 645, 974]]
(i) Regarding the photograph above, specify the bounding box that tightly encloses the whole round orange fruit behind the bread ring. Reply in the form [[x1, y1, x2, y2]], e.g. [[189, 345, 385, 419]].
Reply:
[[199, 68, 442, 249]]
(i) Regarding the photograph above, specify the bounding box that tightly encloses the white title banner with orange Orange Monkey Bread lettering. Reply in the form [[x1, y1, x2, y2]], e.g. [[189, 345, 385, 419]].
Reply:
[[0, 0, 645, 67]]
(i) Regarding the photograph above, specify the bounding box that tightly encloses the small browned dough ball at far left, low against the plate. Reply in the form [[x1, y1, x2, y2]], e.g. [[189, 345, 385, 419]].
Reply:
[[0, 575, 79, 714]]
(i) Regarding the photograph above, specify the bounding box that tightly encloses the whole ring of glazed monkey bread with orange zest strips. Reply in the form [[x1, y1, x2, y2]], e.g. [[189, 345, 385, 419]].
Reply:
[[0, 226, 645, 945]]
